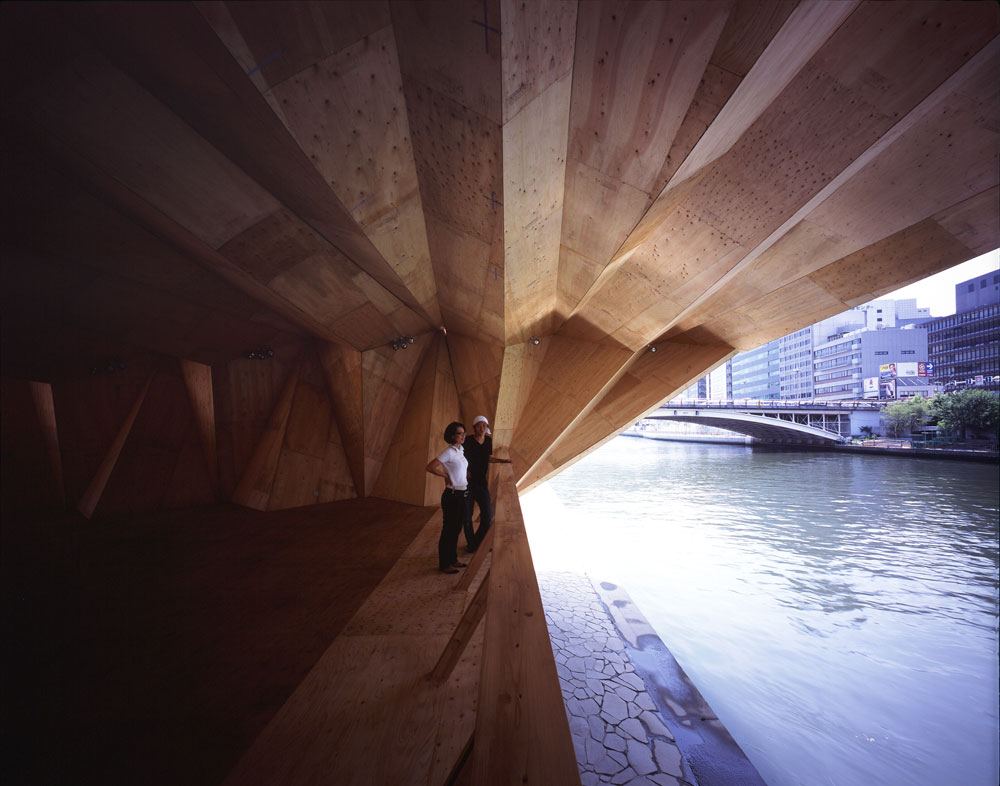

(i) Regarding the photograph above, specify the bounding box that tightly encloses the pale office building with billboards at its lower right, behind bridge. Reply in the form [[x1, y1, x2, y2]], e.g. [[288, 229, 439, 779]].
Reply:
[[813, 325, 928, 401]]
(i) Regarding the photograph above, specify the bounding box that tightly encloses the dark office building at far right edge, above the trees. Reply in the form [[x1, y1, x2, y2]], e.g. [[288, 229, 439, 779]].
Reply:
[[926, 272, 1000, 390]]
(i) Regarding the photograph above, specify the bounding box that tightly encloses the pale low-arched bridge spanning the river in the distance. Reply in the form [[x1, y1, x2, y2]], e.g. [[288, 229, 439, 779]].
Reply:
[[646, 402, 872, 445]]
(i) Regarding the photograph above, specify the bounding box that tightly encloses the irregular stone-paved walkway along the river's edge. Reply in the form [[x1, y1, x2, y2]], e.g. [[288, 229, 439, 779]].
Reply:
[[538, 573, 764, 786]]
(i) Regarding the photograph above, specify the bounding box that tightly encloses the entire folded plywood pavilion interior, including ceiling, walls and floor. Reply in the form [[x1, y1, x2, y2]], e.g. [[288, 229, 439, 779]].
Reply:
[[0, 0, 1000, 786]]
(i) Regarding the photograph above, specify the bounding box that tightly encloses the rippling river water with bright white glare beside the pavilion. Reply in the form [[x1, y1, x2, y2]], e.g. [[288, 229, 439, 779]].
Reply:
[[521, 437, 1000, 786]]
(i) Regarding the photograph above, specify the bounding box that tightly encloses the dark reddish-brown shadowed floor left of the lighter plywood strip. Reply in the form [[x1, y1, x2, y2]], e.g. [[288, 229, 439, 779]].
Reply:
[[0, 499, 438, 785]]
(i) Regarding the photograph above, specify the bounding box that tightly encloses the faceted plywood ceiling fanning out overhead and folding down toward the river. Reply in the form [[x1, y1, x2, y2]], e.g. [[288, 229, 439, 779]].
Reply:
[[0, 0, 1000, 486]]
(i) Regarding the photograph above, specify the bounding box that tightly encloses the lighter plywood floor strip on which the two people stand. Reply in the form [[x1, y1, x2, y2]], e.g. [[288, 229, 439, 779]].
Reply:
[[225, 506, 490, 786]]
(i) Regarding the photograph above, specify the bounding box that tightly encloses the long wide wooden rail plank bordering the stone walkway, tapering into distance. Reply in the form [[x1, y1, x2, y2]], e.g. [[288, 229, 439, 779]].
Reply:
[[472, 464, 580, 786]]
